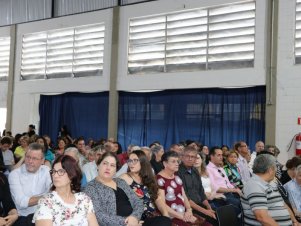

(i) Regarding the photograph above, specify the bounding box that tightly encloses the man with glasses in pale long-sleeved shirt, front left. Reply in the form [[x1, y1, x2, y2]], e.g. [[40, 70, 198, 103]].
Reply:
[[8, 143, 51, 226]]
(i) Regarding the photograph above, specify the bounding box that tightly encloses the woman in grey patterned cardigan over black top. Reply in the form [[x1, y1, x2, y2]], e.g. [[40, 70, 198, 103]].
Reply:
[[85, 152, 143, 226]]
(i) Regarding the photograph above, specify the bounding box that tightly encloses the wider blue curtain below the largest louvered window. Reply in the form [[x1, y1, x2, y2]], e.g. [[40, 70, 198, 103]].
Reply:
[[118, 87, 265, 149]]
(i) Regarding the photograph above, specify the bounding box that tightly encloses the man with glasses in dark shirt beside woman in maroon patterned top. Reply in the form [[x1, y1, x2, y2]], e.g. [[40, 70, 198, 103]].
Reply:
[[178, 146, 218, 226]]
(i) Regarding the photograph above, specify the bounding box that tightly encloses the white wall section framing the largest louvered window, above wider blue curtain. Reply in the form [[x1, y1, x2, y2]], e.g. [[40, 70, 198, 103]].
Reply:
[[117, 0, 266, 91]]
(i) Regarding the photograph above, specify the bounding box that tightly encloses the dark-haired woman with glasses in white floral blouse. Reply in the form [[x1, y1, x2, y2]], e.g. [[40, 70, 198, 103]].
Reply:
[[33, 155, 98, 226]]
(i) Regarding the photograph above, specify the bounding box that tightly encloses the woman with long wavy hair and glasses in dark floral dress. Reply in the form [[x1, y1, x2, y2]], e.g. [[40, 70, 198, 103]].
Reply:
[[120, 150, 171, 226]]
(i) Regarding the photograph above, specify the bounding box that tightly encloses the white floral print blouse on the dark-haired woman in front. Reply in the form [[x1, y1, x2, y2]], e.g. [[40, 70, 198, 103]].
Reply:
[[33, 191, 94, 226]]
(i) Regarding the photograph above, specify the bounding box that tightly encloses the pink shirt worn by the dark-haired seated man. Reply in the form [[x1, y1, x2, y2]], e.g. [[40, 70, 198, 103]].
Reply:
[[207, 162, 234, 192]]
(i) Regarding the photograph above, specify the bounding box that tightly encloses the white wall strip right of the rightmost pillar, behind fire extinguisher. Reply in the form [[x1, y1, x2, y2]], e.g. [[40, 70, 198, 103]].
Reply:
[[276, 0, 301, 163]]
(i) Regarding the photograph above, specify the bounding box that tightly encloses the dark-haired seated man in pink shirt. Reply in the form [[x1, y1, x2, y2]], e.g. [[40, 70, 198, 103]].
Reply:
[[207, 147, 242, 215]]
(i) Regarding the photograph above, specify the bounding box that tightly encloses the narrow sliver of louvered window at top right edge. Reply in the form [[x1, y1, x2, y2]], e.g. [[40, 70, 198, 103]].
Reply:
[[295, 0, 301, 64]]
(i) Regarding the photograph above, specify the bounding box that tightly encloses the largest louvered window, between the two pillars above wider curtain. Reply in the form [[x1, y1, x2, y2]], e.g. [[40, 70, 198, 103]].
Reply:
[[128, 1, 255, 74]]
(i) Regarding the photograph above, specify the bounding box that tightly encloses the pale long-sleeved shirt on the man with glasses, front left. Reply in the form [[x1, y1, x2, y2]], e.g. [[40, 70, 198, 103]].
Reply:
[[8, 164, 51, 216]]
